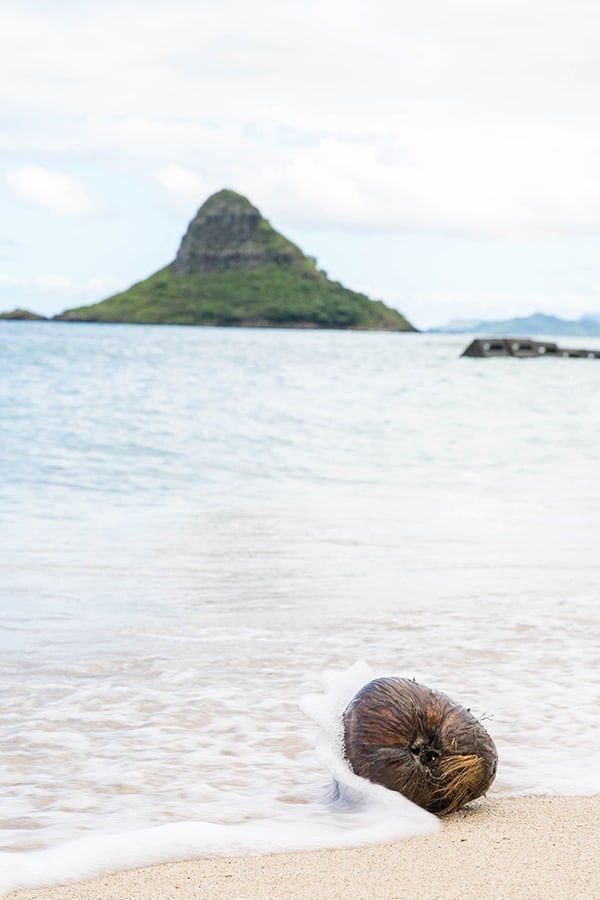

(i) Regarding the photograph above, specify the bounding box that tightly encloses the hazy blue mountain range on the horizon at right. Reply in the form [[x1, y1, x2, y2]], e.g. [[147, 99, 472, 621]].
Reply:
[[428, 313, 600, 337]]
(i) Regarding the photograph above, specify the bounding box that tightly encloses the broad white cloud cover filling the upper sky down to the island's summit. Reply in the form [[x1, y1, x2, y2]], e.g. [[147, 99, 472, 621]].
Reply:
[[0, 0, 600, 234]]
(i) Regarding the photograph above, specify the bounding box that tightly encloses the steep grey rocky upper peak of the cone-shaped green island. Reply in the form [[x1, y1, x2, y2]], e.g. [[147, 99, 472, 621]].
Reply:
[[172, 190, 304, 275]]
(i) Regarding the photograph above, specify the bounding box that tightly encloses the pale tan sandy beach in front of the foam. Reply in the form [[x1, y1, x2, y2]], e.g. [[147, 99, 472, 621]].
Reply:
[[8, 796, 600, 900]]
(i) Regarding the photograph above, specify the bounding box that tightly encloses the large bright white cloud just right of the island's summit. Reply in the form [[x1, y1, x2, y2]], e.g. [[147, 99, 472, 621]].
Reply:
[[248, 117, 600, 236]]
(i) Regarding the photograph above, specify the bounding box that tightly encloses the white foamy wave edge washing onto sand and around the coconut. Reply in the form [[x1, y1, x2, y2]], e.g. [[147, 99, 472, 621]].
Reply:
[[0, 663, 439, 893]]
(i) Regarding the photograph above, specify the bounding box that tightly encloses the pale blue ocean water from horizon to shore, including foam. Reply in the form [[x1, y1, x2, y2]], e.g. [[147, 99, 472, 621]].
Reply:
[[0, 322, 600, 889]]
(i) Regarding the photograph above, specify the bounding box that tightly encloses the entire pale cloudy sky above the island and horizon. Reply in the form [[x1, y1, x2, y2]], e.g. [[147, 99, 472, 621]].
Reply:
[[0, 0, 600, 328]]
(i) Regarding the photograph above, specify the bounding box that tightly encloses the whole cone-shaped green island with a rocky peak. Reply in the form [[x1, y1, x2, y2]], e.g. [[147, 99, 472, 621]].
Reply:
[[54, 190, 416, 331]]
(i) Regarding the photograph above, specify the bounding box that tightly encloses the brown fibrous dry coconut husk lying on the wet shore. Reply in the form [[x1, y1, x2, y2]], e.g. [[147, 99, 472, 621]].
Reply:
[[344, 678, 498, 814]]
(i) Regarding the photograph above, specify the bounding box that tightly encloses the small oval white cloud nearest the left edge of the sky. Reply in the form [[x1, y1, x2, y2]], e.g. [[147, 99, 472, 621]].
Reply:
[[5, 166, 96, 219]]
